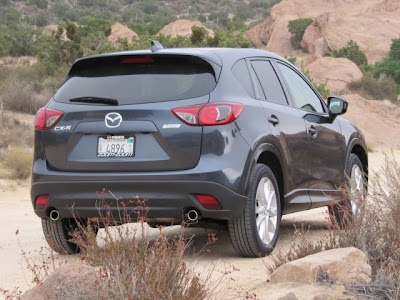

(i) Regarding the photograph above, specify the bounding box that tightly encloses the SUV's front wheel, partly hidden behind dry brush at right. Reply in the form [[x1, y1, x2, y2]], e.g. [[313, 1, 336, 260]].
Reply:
[[328, 153, 366, 229]]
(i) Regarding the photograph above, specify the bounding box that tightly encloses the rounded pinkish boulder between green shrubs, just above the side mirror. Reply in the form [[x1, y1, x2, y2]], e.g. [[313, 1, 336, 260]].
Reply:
[[306, 57, 363, 93]]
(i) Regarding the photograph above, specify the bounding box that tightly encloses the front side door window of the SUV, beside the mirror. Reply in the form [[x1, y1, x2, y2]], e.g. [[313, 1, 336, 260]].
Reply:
[[278, 63, 324, 113]]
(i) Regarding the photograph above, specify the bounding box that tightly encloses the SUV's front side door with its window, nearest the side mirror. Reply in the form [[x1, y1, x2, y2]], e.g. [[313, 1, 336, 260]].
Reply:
[[275, 62, 345, 207]]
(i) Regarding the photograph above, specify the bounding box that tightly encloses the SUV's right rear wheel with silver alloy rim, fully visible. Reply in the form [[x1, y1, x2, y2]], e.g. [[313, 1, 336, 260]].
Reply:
[[228, 164, 282, 257]]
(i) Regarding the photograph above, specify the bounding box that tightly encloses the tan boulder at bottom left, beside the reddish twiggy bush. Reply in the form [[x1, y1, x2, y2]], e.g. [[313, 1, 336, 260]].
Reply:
[[20, 263, 100, 300]]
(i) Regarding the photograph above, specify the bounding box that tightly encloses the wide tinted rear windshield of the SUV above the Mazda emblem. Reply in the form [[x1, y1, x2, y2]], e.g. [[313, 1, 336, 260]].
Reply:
[[54, 55, 216, 105]]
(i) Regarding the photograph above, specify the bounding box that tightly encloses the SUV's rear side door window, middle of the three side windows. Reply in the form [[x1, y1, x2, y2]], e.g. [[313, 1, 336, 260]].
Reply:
[[251, 60, 287, 104]]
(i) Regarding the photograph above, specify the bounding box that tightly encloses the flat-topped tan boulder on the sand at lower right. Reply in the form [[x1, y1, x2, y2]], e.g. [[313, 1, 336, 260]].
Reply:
[[270, 247, 371, 284]]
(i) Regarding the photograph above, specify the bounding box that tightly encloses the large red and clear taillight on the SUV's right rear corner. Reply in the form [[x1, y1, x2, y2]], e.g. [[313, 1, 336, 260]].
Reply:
[[172, 102, 243, 126]]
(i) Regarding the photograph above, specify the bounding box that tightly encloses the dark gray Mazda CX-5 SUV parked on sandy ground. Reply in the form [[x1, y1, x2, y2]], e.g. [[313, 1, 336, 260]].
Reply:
[[31, 43, 368, 257]]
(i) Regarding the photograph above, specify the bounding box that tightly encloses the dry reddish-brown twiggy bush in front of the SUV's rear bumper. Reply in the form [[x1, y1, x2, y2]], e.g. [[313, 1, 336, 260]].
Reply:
[[0, 199, 219, 300]]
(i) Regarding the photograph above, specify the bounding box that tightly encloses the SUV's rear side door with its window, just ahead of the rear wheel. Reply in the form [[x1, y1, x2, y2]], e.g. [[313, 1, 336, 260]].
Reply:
[[249, 59, 311, 213]]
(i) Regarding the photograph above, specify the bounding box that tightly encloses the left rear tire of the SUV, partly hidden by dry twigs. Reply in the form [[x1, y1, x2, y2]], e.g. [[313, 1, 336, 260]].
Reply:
[[42, 219, 98, 254]]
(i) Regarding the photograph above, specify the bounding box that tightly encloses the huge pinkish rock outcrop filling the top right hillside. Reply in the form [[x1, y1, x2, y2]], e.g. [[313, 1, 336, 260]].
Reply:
[[247, 0, 400, 63]]
